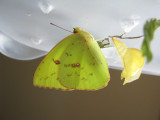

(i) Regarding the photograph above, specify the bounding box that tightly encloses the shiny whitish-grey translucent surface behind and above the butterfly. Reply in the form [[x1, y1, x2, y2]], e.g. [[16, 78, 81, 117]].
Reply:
[[0, 0, 160, 75]]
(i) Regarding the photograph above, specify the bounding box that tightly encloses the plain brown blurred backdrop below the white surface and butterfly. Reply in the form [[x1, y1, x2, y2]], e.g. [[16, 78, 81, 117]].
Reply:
[[0, 54, 160, 120]]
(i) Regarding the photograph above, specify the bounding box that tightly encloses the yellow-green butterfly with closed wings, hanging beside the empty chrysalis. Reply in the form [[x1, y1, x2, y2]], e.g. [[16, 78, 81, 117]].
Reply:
[[33, 27, 110, 90]]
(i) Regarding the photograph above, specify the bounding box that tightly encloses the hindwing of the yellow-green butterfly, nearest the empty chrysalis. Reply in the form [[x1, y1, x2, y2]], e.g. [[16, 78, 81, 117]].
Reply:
[[59, 31, 110, 90]]
